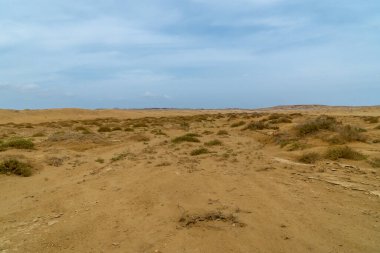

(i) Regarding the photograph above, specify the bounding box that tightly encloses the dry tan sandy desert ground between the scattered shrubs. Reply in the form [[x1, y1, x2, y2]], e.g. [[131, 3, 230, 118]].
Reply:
[[0, 107, 380, 253]]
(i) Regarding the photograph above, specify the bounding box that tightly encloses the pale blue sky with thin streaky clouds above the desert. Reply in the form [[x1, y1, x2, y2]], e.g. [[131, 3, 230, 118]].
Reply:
[[0, 0, 380, 109]]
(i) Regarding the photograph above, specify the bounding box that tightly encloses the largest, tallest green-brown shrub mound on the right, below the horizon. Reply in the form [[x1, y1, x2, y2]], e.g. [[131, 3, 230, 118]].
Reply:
[[296, 115, 340, 136]]
